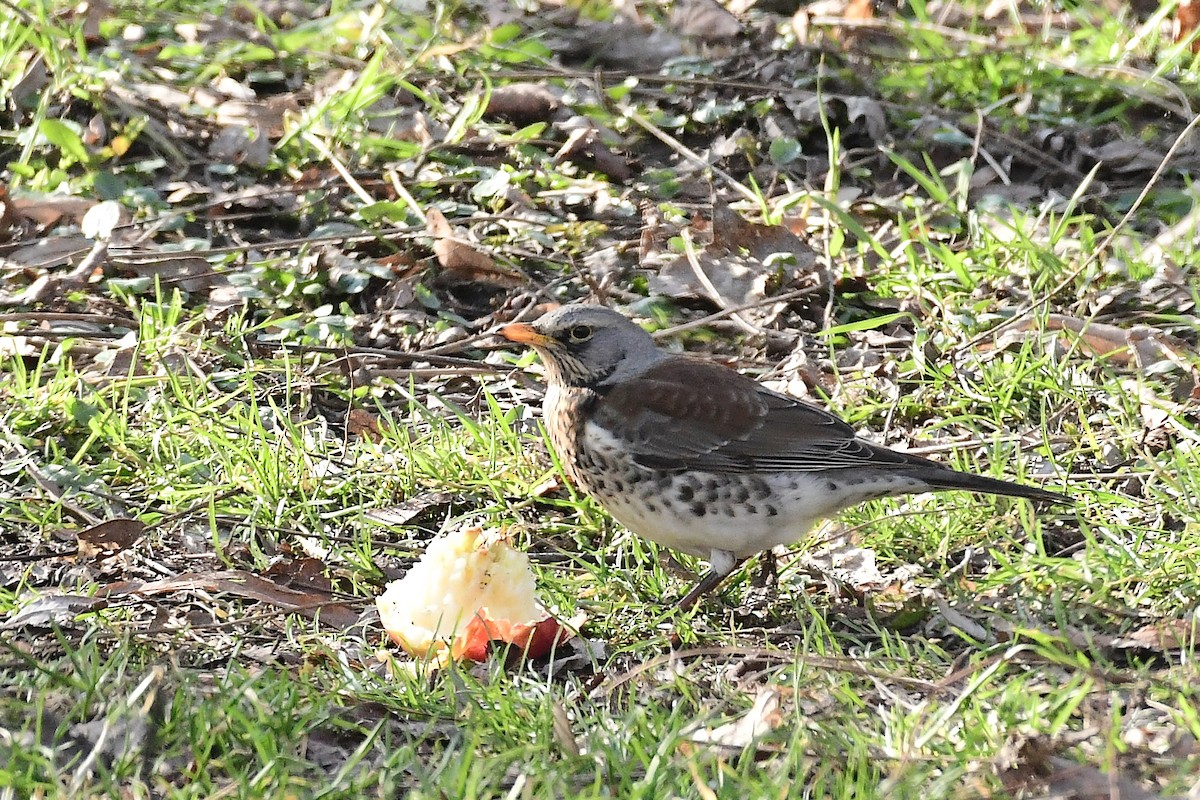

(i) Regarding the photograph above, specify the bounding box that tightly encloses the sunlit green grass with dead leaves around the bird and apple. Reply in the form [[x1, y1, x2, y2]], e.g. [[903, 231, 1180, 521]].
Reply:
[[0, 0, 1200, 799]]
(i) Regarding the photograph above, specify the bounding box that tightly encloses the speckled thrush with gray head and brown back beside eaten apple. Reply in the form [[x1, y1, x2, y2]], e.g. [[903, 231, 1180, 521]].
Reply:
[[498, 303, 1072, 610]]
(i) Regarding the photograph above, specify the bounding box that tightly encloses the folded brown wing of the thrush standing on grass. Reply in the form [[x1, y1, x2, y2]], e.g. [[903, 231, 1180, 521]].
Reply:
[[594, 359, 907, 473]]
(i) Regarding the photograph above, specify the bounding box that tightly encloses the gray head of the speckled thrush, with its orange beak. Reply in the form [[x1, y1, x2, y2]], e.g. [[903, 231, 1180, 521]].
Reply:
[[500, 305, 666, 386]]
